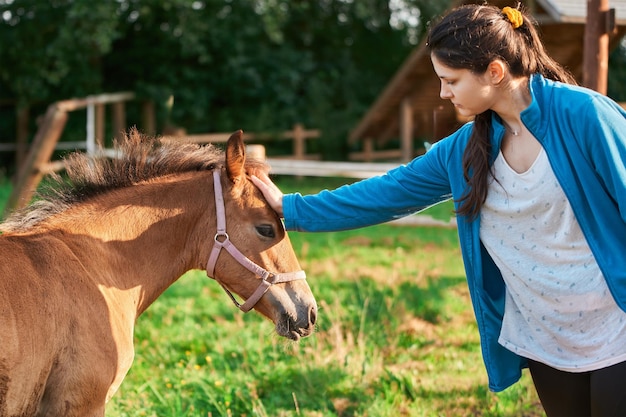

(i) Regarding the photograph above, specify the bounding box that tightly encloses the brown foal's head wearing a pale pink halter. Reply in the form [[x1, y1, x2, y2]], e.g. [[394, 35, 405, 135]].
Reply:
[[207, 131, 317, 340]]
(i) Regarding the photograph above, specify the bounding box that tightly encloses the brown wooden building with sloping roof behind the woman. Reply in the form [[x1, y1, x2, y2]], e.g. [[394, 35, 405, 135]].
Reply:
[[349, 0, 626, 161]]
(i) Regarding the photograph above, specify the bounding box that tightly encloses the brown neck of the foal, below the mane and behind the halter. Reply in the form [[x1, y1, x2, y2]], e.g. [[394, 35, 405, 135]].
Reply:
[[49, 173, 215, 314]]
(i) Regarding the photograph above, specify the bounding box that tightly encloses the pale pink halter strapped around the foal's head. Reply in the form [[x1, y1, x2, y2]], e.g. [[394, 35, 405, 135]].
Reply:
[[206, 170, 306, 313]]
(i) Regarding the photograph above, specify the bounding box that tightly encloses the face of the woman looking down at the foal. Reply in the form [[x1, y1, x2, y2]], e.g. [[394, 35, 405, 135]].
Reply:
[[430, 54, 497, 117]]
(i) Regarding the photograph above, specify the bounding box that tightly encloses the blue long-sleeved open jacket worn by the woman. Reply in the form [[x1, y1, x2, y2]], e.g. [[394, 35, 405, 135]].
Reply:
[[283, 75, 626, 391]]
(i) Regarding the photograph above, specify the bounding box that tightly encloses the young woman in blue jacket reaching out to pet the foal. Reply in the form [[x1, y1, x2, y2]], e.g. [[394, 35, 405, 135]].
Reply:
[[253, 5, 626, 416]]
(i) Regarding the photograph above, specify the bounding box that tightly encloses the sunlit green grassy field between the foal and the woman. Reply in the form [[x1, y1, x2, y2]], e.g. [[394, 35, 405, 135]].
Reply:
[[0, 178, 544, 417]]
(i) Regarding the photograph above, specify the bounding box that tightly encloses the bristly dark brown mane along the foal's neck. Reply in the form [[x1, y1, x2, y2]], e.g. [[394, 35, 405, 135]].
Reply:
[[0, 128, 262, 232]]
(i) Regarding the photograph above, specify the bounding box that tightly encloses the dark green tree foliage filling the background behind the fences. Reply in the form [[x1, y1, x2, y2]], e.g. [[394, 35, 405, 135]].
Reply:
[[0, 0, 442, 162]]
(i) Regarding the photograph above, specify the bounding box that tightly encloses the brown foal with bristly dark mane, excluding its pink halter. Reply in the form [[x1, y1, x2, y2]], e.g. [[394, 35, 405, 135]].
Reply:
[[0, 131, 316, 417]]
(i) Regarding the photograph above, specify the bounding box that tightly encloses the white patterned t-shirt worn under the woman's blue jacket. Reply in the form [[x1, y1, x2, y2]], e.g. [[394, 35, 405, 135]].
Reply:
[[480, 149, 626, 372]]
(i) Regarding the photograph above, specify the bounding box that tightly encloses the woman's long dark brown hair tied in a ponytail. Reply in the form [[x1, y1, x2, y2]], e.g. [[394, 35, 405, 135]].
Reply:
[[426, 4, 576, 218]]
